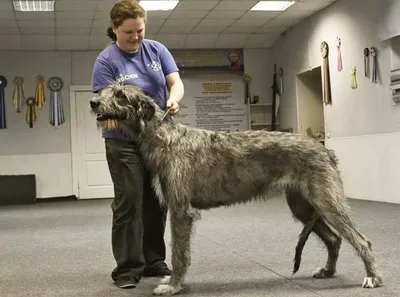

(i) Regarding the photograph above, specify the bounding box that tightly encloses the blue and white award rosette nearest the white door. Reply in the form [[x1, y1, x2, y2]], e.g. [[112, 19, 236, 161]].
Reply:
[[47, 76, 65, 127]]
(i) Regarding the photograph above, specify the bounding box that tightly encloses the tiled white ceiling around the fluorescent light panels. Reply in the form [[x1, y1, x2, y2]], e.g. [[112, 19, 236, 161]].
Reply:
[[0, 0, 336, 50]]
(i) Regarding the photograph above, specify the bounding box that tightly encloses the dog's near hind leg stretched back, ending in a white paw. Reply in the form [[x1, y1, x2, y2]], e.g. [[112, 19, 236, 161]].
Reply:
[[305, 180, 382, 288]]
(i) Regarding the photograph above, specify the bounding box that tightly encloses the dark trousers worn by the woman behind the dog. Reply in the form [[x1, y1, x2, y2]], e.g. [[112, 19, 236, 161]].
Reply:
[[105, 138, 167, 281]]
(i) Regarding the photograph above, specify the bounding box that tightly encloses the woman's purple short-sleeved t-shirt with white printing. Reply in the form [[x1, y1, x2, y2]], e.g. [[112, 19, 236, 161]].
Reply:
[[92, 39, 179, 139]]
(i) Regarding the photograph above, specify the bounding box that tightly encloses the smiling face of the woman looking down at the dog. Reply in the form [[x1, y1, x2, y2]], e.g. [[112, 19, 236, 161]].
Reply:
[[113, 17, 145, 53]]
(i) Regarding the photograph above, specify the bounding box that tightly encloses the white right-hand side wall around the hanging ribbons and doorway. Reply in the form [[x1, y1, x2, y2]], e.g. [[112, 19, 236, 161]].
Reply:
[[273, 0, 400, 203]]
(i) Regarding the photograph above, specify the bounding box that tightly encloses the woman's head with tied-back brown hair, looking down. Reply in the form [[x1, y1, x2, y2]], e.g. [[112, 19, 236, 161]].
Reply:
[[107, 0, 146, 52]]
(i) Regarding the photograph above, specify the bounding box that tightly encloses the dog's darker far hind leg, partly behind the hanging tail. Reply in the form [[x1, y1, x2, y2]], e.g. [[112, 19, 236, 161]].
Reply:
[[286, 188, 342, 278]]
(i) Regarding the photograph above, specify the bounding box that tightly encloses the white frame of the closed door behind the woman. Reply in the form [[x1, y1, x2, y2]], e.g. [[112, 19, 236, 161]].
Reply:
[[69, 85, 92, 199]]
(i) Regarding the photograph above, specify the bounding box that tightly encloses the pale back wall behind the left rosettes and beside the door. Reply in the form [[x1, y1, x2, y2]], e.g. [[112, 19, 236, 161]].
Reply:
[[0, 49, 272, 198]]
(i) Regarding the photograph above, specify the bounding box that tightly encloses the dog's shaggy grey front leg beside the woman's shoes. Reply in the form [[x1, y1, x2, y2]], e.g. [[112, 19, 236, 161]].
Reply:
[[153, 209, 194, 296]]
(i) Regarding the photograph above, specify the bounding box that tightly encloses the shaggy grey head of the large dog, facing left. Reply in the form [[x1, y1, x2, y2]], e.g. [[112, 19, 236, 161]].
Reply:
[[90, 83, 157, 131]]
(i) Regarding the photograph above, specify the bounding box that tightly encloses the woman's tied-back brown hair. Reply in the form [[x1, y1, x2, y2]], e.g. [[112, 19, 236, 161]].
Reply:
[[107, 0, 146, 41]]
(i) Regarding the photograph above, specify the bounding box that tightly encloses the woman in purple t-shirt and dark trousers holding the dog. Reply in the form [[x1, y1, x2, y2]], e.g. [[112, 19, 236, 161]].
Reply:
[[92, 0, 184, 288]]
